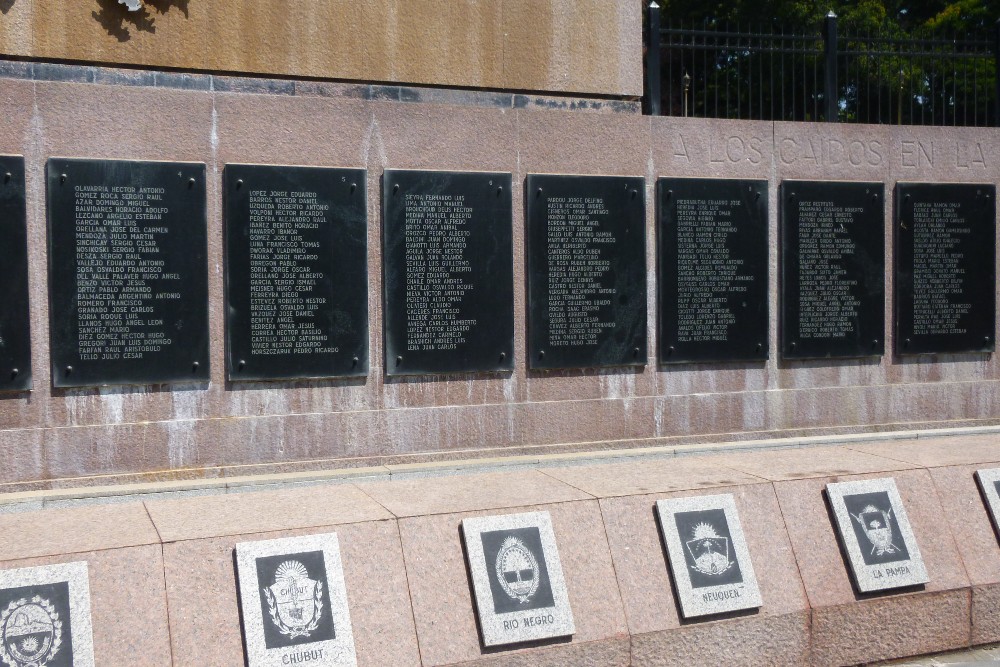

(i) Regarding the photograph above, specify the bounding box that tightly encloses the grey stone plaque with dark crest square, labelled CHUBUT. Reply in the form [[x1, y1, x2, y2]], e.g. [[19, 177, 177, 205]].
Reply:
[[236, 533, 358, 667]]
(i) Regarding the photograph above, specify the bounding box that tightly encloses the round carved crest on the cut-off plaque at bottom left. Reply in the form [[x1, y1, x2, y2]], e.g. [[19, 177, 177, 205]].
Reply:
[[0, 595, 62, 667]]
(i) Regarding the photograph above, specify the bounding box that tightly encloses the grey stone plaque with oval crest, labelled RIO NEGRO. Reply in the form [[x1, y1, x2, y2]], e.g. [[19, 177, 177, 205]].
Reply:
[[462, 512, 576, 646]]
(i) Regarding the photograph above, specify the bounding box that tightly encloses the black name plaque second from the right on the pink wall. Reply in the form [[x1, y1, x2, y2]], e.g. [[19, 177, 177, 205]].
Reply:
[[779, 181, 885, 359]]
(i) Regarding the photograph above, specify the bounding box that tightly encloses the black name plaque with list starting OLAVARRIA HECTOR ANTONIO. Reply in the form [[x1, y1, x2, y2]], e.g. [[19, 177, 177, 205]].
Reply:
[[47, 158, 209, 387]]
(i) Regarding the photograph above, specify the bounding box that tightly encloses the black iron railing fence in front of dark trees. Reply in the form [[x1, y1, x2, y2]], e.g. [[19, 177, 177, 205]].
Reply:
[[645, 3, 1000, 126]]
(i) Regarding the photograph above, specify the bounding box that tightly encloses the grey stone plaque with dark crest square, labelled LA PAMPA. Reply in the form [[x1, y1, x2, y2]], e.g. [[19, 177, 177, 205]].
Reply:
[[826, 477, 929, 593]]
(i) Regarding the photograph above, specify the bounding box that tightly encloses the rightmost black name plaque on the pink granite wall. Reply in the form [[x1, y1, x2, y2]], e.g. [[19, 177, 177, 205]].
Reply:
[[894, 183, 996, 354]]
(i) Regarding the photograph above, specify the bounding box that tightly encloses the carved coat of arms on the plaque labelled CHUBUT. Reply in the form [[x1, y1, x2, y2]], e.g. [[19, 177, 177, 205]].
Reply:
[[263, 560, 323, 639]]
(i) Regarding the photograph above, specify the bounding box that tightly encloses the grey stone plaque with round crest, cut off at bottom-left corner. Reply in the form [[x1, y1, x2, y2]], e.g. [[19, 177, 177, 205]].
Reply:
[[0, 562, 94, 667]]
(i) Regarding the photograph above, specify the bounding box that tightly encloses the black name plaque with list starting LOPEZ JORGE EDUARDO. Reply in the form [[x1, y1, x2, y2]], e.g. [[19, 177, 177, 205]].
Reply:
[[224, 164, 368, 380]]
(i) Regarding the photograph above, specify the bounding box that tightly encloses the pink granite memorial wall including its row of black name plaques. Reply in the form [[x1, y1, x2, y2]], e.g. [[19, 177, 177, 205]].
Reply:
[[0, 64, 1000, 490]]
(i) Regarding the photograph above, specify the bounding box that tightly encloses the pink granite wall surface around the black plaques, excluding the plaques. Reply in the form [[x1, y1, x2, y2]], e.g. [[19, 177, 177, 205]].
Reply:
[[0, 68, 1000, 489]]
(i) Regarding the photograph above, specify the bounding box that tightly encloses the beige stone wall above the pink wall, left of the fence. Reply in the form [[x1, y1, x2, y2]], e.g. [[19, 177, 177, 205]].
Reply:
[[0, 0, 642, 97]]
